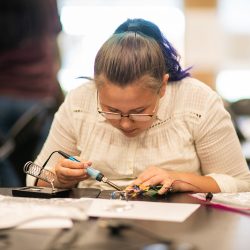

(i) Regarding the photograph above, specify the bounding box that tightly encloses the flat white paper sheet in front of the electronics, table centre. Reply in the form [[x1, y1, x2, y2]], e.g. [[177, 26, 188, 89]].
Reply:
[[87, 199, 200, 222]]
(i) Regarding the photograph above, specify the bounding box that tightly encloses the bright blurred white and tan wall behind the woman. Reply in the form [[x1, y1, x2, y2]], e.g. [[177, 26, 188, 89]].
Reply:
[[58, 0, 250, 102]]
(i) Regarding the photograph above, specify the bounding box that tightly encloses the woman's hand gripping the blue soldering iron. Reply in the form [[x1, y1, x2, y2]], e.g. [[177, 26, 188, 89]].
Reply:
[[54, 159, 91, 188]]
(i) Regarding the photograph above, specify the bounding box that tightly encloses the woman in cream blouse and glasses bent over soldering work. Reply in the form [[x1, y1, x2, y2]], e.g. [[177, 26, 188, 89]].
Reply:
[[28, 19, 250, 194]]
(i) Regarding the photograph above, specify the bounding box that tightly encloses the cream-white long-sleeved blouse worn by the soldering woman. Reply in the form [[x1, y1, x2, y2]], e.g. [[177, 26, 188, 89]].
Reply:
[[27, 77, 250, 192]]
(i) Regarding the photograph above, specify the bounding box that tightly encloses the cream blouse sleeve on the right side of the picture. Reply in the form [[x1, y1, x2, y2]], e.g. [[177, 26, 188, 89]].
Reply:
[[195, 94, 250, 192]]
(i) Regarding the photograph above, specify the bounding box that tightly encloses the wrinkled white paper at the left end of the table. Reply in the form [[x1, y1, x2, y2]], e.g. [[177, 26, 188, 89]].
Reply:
[[0, 195, 91, 229]]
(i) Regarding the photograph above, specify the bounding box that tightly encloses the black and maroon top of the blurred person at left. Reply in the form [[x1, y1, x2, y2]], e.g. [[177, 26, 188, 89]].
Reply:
[[0, 0, 61, 99]]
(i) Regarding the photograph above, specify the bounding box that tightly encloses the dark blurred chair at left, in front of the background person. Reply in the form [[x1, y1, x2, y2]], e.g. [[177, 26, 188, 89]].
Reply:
[[0, 100, 55, 186]]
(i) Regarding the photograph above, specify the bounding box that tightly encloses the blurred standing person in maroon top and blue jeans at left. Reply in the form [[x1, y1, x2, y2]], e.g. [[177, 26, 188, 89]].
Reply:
[[0, 0, 64, 186]]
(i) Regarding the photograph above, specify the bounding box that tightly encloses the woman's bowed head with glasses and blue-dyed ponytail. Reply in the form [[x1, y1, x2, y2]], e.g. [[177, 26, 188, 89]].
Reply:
[[94, 19, 188, 137]]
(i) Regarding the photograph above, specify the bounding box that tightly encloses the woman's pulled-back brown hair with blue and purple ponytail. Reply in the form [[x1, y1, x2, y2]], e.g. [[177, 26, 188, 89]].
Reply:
[[94, 19, 189, 91]]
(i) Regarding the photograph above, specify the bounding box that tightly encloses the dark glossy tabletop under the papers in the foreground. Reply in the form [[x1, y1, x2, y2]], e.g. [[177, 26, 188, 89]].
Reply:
[[0, 188, 250, 250]]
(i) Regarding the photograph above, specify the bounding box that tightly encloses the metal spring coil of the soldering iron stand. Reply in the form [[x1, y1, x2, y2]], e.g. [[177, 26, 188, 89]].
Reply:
[[23, 161, 55, 190]]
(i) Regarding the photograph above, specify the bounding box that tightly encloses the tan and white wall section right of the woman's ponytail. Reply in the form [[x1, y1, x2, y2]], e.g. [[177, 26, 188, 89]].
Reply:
[[184, 0, 250, 101]]
